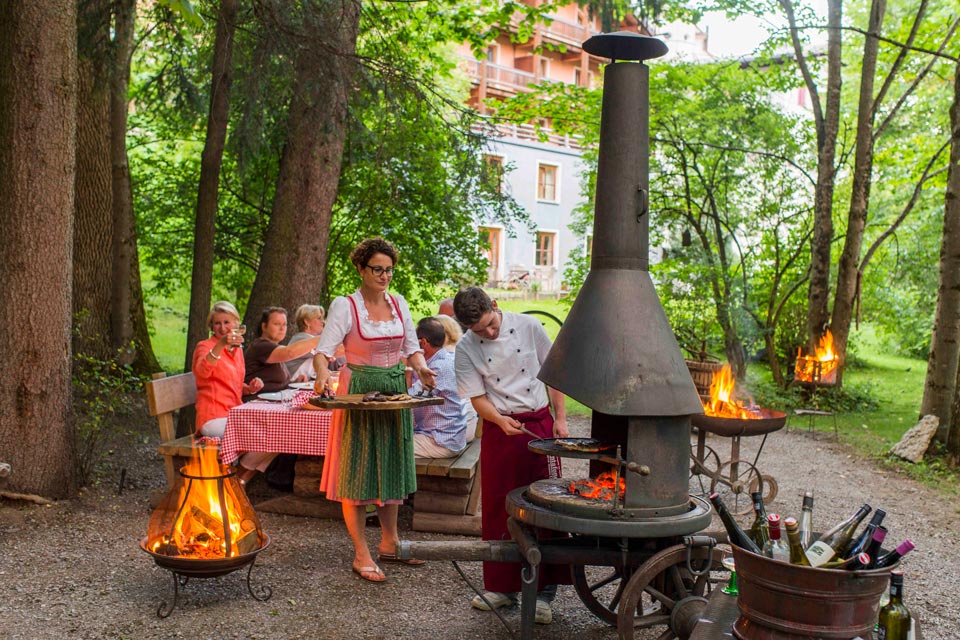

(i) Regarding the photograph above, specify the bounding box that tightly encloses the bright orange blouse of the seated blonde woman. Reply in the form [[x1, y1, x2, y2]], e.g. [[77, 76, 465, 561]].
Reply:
[[193, 336, 246, 431]]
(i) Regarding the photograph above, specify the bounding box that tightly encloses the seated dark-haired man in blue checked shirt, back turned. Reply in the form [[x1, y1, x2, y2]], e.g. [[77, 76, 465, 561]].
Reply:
[[410, 317, 467, 458]]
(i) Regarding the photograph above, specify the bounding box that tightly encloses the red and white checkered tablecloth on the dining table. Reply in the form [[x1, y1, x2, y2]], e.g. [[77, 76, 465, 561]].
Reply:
[[220, 391, 331, 464]]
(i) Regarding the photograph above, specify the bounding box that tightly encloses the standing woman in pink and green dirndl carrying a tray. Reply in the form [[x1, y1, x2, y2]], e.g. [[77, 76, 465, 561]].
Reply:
[[314, 238, 435, 582]]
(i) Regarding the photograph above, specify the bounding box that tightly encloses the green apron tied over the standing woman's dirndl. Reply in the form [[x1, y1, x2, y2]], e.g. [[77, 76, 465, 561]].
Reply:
[[337, 362, 417, 502]]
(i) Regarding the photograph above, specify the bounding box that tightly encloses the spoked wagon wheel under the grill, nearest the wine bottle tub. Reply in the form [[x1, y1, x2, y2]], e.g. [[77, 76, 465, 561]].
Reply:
[[617, 544, 723, 640]]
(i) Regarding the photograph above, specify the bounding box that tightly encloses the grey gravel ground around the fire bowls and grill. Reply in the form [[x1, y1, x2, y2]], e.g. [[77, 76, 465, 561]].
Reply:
[[0, 412, 960, 640]]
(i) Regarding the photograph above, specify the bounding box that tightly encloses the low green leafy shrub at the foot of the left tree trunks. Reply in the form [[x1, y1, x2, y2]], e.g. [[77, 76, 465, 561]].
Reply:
[[73, 322, 143, 486]]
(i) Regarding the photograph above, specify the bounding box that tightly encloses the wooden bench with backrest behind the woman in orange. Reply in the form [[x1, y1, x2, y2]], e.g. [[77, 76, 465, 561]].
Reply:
[[146, 372, 217, 490]]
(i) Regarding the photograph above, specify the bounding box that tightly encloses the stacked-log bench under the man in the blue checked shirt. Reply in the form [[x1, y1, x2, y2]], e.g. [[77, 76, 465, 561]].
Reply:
[[413, 435, 480, 535]]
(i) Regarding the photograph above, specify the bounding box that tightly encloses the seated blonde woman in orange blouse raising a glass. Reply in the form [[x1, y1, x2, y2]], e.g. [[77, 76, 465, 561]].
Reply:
[[193, 301, 276, 484]]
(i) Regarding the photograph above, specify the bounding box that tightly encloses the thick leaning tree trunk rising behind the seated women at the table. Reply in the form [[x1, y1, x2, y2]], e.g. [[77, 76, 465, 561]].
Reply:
[[245, 0, 360, 327]]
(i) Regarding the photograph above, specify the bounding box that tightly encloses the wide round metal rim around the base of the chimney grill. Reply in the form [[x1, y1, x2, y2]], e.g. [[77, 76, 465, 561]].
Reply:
[[507, 478, 711, 538]]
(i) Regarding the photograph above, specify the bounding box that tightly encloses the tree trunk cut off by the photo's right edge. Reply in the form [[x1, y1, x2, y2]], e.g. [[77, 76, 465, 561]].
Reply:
[[920, 61, 960, 450]]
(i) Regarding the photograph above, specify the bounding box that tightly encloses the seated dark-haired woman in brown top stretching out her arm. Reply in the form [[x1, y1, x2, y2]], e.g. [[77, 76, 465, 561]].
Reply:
[[245, 307, 320, 391]]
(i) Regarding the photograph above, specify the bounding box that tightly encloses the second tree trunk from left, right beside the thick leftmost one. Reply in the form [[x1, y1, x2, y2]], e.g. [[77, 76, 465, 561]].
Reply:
[[73, 0, 113, 359]]
